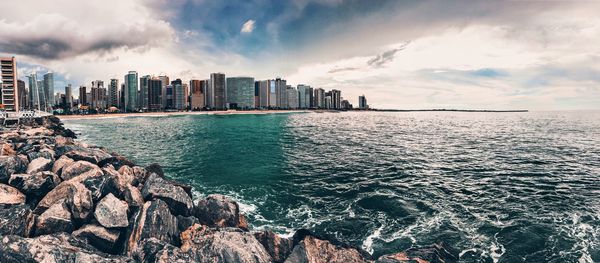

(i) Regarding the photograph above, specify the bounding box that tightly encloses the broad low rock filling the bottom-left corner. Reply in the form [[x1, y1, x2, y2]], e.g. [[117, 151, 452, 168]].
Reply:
[[0, 233, 134, 263]]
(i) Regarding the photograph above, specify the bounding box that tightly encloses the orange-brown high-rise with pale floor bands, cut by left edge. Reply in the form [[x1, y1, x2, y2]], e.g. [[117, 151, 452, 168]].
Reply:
[[0, 57, 20, 111]]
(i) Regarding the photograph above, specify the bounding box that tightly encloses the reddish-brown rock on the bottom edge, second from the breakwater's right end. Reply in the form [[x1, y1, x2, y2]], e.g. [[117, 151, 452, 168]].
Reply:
[[285, 236, 367, 263]]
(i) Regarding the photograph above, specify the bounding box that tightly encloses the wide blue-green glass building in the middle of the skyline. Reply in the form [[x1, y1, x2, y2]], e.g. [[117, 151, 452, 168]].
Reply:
[[226, 77, 255, 109]]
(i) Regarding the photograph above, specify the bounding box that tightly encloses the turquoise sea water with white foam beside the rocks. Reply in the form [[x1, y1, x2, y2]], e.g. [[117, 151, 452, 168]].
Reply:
[[65, 112, 600, 262]]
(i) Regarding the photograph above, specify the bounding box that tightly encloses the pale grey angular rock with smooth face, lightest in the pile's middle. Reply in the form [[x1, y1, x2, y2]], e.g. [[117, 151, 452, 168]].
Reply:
[[94, 193, 129, 228]]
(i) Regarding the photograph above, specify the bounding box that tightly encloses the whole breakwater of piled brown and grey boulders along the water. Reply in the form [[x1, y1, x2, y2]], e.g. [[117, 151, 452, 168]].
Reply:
[[0, 117, 457, 263]]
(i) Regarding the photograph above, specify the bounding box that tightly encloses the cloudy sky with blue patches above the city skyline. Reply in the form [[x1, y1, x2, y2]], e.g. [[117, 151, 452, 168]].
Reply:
[[0, 0, 600, 110]]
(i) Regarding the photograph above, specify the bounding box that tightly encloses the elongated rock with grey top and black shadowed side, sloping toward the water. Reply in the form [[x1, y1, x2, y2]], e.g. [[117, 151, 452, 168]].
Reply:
[[142, 174, 194, 216]]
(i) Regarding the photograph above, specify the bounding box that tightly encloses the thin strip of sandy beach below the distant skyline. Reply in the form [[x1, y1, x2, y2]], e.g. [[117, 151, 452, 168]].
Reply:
[[56, 110, 311, 120]]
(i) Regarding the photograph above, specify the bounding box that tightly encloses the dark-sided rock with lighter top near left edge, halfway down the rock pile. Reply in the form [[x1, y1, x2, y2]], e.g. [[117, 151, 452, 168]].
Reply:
[[8, 172, 60, 200]]
